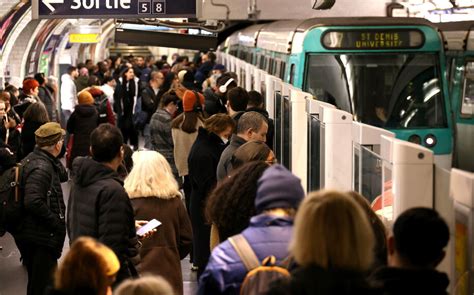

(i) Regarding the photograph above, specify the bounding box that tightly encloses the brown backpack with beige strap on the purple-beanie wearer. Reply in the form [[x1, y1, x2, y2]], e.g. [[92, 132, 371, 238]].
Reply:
[[229, 234, 290, 295]]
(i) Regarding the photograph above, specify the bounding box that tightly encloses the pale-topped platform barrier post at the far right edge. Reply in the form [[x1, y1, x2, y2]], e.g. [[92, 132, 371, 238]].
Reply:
[[450, 169, 474, 295]]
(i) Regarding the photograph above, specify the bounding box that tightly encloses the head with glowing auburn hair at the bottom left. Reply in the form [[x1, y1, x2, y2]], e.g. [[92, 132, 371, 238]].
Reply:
[[54, 237, 120, 295]]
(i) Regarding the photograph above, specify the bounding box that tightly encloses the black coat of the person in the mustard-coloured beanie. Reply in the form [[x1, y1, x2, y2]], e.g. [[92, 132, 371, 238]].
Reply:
[[67, 105, 99, 167]]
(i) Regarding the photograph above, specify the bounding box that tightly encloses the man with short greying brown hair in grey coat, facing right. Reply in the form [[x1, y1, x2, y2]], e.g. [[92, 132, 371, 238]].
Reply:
[[217, 112, 268, 180]]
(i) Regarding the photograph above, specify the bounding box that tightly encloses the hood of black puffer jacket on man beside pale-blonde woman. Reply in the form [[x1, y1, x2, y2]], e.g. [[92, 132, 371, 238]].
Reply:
[[72, 157, 123, 187]]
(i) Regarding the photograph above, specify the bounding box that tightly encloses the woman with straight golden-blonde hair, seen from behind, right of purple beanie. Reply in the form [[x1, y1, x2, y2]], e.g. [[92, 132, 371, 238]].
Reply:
[[269, 191, 378, 295]]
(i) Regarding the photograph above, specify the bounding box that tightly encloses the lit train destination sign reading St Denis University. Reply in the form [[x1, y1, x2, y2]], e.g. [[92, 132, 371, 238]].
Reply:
[[322, 29, 425, 50]]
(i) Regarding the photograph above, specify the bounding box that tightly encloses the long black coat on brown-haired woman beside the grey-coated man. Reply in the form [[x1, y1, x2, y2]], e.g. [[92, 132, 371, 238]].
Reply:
[[188, 127, 225, 271]]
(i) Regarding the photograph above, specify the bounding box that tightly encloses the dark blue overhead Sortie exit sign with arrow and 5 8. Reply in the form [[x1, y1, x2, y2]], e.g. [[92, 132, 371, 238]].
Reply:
[[32, 0, 197, 19]]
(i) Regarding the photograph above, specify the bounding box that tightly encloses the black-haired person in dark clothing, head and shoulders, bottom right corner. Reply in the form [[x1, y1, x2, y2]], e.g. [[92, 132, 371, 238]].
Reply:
[[371, 208, 449, 295]]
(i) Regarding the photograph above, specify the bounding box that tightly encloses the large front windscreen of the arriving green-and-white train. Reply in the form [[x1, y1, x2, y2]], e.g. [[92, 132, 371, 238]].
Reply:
[[303, 53, 447, 129]]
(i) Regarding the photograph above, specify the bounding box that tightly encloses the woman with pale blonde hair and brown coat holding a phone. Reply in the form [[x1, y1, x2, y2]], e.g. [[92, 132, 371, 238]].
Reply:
[[124, 151, 192, 294]]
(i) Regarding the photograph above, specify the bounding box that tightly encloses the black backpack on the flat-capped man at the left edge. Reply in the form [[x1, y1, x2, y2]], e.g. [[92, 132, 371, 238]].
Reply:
[[0, 159, 30, 237]]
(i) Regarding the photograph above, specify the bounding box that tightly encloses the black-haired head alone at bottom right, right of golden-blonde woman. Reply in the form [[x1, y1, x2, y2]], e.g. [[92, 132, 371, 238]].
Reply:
[[387, 208, 449, 268]]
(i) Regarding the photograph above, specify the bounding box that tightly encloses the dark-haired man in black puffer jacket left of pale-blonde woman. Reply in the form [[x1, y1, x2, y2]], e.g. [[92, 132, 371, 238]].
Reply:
[[67, 123, 139, 283]]
